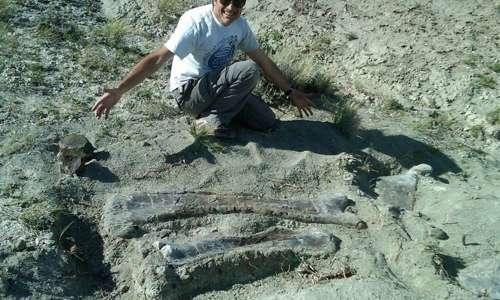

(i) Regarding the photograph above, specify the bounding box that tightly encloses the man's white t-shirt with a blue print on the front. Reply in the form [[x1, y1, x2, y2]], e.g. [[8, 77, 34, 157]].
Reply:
[[165, 4, 259, 91]]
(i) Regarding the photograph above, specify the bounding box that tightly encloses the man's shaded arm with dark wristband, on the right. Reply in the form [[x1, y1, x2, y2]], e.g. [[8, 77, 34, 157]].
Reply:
[[247, 48, 313, 117]]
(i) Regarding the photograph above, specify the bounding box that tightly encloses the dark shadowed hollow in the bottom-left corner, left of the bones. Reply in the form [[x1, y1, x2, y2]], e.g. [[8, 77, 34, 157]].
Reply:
[[0, 213, 114, 299]]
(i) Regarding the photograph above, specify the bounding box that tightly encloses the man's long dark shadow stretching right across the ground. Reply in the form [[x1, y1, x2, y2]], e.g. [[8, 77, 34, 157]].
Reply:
[[166, 120, 462, 196]]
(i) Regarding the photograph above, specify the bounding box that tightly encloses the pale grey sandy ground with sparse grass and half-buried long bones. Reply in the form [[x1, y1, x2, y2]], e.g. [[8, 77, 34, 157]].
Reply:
[[0, 0, 500, 299]]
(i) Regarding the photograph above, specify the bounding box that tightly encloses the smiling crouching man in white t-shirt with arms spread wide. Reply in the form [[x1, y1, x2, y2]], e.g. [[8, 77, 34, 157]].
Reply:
[[92, 0, 312, 138]]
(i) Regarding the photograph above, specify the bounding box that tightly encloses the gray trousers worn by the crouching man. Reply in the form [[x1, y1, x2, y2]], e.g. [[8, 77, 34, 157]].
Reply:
[[174, 60, 276, 130]]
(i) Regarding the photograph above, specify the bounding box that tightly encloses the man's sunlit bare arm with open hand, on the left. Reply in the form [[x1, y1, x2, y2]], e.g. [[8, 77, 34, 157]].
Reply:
[[92, 46, 174, 119]]
